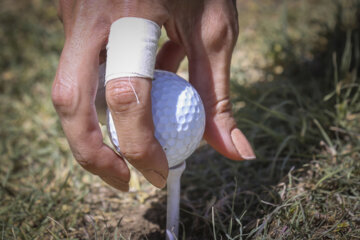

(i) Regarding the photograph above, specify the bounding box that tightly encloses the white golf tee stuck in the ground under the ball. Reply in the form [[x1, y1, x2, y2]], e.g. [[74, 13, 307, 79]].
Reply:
[[166, 161, 186, 240]]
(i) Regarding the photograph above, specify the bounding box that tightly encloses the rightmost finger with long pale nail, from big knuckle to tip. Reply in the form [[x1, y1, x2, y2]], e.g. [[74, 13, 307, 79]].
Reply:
[[187, 14, 255, 160]]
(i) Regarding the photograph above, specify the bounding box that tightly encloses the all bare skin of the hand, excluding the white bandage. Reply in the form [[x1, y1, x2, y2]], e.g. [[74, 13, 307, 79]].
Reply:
[[52, 0, 255, 191]]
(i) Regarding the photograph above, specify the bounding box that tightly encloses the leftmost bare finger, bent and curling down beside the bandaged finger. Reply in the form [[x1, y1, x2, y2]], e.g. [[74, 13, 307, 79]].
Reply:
[[52, 23, 130, 191]]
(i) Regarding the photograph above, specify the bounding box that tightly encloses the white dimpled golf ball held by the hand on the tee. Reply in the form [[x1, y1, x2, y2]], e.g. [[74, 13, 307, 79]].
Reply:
[[107, 70, 205, 167]]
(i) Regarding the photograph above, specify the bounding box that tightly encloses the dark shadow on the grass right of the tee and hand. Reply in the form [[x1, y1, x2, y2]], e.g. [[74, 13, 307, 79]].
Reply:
[[144, 5, 359, 239]]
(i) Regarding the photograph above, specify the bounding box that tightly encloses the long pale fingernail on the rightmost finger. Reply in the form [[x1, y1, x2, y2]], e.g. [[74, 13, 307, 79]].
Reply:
[[230, 128, 256, 160]]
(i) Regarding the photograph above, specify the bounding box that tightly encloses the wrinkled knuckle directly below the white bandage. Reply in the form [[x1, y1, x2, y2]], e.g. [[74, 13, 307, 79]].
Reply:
[[106, 80, 140, 112]]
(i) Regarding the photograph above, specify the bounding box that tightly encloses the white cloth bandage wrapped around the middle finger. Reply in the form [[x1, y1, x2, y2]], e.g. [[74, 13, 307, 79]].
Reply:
[[105, 17, 161, 84]]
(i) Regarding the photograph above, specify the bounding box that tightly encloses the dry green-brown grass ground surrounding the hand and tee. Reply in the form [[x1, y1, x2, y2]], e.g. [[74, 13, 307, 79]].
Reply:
[[0, 0, 360, 239]]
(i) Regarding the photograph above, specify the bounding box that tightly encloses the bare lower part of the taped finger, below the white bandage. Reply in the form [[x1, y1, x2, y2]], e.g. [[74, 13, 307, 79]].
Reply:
[[106, 77, 168, 188]]
